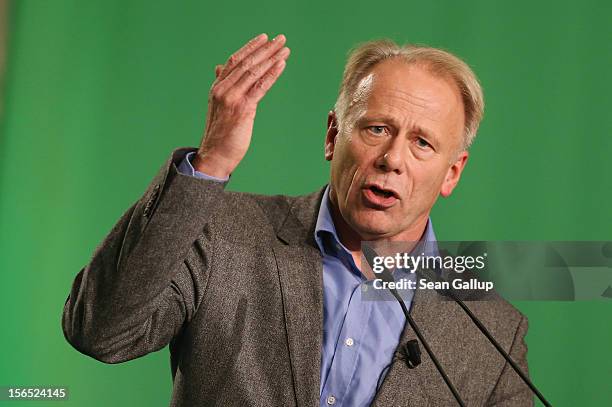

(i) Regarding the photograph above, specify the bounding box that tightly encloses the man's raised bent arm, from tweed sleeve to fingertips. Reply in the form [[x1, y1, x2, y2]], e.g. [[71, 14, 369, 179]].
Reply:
[[62, 31, 289, 363]]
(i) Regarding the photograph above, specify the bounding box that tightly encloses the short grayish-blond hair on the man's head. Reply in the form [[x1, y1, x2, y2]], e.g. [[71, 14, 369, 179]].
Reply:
[[334, 39, 484, 150]]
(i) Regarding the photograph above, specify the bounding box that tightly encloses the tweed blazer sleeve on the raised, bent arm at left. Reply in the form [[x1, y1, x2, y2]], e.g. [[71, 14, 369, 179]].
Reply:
[[62, 149, 226, 363]]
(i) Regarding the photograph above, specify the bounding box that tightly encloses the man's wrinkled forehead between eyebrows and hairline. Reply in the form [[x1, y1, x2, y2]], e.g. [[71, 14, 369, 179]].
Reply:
[[354, 59, 464, 142]]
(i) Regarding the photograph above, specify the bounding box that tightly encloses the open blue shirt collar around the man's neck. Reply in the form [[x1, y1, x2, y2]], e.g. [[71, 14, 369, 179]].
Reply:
[[314, 185, 436, 254]]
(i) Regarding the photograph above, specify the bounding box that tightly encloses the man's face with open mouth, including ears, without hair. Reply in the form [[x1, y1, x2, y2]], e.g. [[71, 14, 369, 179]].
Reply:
[[325, 59, 467, 240]]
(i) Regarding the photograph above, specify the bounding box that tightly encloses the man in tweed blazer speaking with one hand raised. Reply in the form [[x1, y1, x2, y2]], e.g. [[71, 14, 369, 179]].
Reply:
[[62, 34, 532, 406]]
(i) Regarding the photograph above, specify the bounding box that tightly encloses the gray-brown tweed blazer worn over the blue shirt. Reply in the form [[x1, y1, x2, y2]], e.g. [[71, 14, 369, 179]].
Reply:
[[62, 148, 533, 407]]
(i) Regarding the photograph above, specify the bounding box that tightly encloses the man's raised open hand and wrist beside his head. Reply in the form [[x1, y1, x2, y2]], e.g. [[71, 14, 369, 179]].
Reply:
[[193, 34, 290, 178]]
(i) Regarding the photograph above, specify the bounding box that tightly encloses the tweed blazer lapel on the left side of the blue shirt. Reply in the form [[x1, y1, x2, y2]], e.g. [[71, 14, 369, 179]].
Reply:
[[273, 191, 323, 407]]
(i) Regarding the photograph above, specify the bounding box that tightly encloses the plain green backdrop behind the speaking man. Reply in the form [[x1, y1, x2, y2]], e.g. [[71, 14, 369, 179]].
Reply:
[[0, 0, 612, 406]]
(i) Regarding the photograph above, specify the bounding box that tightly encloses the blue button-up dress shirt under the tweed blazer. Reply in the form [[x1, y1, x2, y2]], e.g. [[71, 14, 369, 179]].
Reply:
[[178, 152, 436, 407]]
